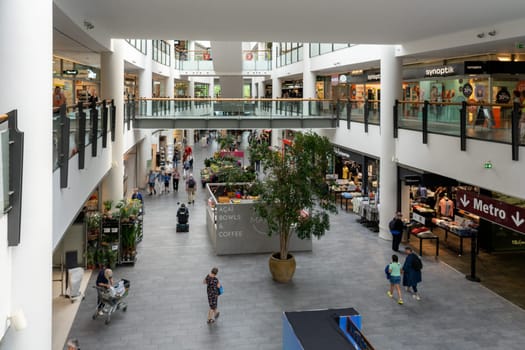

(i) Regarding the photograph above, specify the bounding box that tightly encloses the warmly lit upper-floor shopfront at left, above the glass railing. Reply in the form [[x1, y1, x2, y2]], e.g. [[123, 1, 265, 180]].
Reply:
[[53, 56, 100, 104]]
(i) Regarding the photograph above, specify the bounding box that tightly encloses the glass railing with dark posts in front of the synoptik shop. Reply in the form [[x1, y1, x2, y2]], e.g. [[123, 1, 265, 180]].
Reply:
[[393, 100, 525, 161]]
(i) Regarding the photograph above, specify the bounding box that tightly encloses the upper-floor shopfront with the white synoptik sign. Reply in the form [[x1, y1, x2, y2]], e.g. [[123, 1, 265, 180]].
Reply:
[[403, 61, 525, 128]]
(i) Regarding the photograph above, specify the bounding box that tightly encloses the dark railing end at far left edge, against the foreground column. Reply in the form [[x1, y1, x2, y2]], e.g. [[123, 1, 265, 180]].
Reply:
[[0, 110, 24, 246]]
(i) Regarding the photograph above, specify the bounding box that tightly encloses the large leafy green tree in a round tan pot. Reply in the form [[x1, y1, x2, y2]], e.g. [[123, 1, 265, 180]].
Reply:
[[250, 132, 336, 282]]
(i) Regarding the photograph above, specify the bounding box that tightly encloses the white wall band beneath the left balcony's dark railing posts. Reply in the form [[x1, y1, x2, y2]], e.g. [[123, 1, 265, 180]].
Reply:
[[53, 134, 111, 249]]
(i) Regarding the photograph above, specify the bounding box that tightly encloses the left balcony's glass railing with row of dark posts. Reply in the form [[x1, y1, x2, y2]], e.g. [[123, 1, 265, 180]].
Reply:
[[53, 100, 116, 188]]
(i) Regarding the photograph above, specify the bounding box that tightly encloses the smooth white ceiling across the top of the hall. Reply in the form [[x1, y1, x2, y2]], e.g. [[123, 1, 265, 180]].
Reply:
[[55, 0, 525, 44]]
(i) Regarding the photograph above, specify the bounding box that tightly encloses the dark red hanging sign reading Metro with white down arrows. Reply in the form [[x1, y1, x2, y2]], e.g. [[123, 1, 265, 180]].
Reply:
[[456, 190, 525, 234]]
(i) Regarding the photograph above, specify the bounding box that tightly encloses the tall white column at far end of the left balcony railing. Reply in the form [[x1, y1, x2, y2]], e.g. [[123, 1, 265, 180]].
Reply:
[[100, 39, 124, 201]]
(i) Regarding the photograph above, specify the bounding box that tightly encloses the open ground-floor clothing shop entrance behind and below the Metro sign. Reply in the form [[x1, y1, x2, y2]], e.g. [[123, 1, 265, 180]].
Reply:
[[398, 168, 525, 309]]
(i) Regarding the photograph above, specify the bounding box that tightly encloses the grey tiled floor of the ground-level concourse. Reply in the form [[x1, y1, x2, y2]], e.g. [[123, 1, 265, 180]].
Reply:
[[66, 138, 525, 350]]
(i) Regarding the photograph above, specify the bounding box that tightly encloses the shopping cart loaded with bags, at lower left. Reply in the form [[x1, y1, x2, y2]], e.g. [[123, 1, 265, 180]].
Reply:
[[92, 279, 130, 324]]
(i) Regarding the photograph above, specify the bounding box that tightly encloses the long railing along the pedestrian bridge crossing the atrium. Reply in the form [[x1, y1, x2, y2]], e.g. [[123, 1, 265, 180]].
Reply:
[[126, 98, 337, 129]]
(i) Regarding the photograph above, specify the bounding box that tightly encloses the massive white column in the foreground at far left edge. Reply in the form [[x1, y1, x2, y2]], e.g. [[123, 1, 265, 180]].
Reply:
[[0, 0, 51, 350]]
